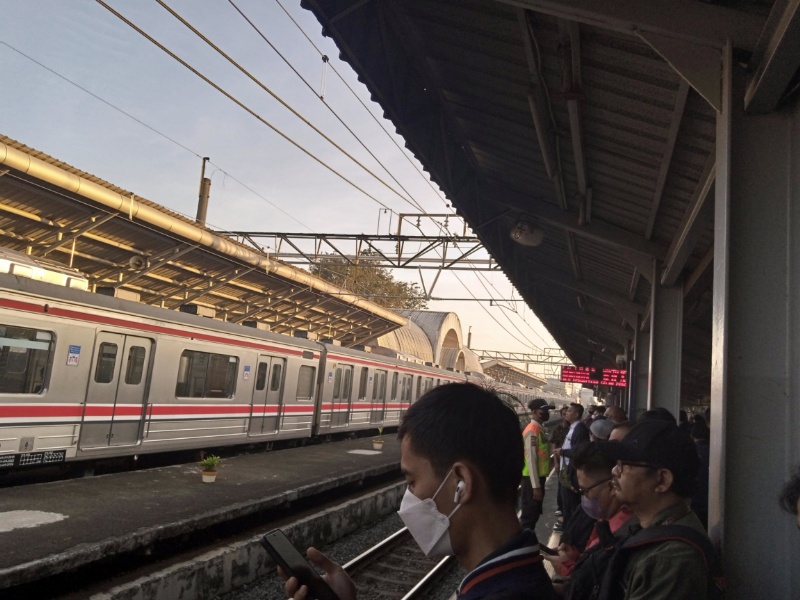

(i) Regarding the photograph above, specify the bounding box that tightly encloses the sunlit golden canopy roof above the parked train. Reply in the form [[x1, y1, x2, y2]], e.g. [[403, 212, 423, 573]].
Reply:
[[0, 136, 406, 346]]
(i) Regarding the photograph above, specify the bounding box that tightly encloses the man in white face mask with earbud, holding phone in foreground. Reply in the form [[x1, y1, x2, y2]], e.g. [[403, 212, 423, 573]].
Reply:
[[285, 383, 554, 600]]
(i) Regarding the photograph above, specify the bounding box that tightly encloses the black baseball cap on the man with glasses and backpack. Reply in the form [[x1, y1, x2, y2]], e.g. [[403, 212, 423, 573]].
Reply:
[[598, 419, 700, 491]]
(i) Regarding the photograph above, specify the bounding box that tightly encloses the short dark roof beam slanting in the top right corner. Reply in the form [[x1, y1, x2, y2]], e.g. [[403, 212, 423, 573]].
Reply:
[[744, 0, 800, 113]]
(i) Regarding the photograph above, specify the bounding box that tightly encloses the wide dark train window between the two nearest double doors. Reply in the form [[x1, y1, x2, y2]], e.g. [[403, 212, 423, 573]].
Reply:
[[175, 350, 239, 398]]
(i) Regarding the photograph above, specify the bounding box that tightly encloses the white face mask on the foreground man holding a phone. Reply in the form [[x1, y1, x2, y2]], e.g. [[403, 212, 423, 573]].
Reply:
[[397, 469, 461, 558]]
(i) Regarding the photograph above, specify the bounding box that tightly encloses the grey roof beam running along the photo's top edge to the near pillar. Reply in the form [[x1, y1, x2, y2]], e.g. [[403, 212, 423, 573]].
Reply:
[[497, 0, 764, 51]]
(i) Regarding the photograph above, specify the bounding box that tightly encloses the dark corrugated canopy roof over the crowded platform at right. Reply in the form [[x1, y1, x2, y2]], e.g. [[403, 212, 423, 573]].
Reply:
[[302, 0, 797, 400]]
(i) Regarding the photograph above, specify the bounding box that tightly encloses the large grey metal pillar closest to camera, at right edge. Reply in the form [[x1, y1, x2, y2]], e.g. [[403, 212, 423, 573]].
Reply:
[[709, 41, 800, 599]]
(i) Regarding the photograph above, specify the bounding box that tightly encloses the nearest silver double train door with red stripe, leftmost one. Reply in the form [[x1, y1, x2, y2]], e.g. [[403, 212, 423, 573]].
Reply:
[[81, 332, 153, 448]]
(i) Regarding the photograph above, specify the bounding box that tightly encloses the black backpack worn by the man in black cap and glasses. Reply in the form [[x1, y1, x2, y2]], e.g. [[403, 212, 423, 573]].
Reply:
[[565, 521, 725, 600]]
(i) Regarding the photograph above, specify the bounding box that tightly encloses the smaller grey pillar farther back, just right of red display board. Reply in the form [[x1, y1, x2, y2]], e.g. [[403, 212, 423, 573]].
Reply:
[[647, 279, 683, 419]]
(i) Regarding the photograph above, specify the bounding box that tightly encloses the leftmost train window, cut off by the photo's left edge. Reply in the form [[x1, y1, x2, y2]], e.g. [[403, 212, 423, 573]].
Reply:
[[0, 325, 53, 394]]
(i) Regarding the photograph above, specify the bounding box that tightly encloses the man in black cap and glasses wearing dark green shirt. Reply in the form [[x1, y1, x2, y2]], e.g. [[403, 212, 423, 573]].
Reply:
[[598, 419, 714, 600]]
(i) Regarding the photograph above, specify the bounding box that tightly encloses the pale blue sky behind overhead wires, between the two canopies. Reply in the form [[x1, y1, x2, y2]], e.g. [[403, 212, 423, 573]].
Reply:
[[0, 0, 555, 376]]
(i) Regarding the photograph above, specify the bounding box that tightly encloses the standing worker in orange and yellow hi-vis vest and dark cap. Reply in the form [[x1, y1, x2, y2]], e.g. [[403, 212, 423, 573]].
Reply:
[[519, 398, 555, 529]]
